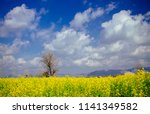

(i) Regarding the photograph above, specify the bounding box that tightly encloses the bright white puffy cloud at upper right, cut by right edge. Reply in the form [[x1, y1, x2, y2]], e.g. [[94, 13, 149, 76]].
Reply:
[[102, 10, 150, 44]]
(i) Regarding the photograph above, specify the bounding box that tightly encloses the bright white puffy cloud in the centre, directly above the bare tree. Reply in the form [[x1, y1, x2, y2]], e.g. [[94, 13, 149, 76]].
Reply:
[[44, 28, 92, 55]]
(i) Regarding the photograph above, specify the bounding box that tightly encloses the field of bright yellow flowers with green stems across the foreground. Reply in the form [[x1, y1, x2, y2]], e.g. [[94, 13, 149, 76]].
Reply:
[[0, 71, 150, 97]]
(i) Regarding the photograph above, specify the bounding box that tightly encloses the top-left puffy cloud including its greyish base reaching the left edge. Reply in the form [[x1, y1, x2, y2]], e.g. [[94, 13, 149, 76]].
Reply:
[[0, 4, 39, 37]]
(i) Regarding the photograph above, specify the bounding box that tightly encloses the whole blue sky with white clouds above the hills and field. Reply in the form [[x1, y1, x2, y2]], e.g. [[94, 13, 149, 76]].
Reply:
[[0, 0, 150, 76]]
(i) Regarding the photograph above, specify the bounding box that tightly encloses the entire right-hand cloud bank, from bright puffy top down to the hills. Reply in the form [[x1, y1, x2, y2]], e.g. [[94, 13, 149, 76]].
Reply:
[[74, 10, 150, 69]]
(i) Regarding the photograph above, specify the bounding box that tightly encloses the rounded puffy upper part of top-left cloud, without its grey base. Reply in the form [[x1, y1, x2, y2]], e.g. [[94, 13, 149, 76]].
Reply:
[[4, 4, 36, 29]]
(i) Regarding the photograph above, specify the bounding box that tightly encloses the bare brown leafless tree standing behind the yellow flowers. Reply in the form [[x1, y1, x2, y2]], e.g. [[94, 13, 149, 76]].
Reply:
[[42, 52, 58, 76]]
